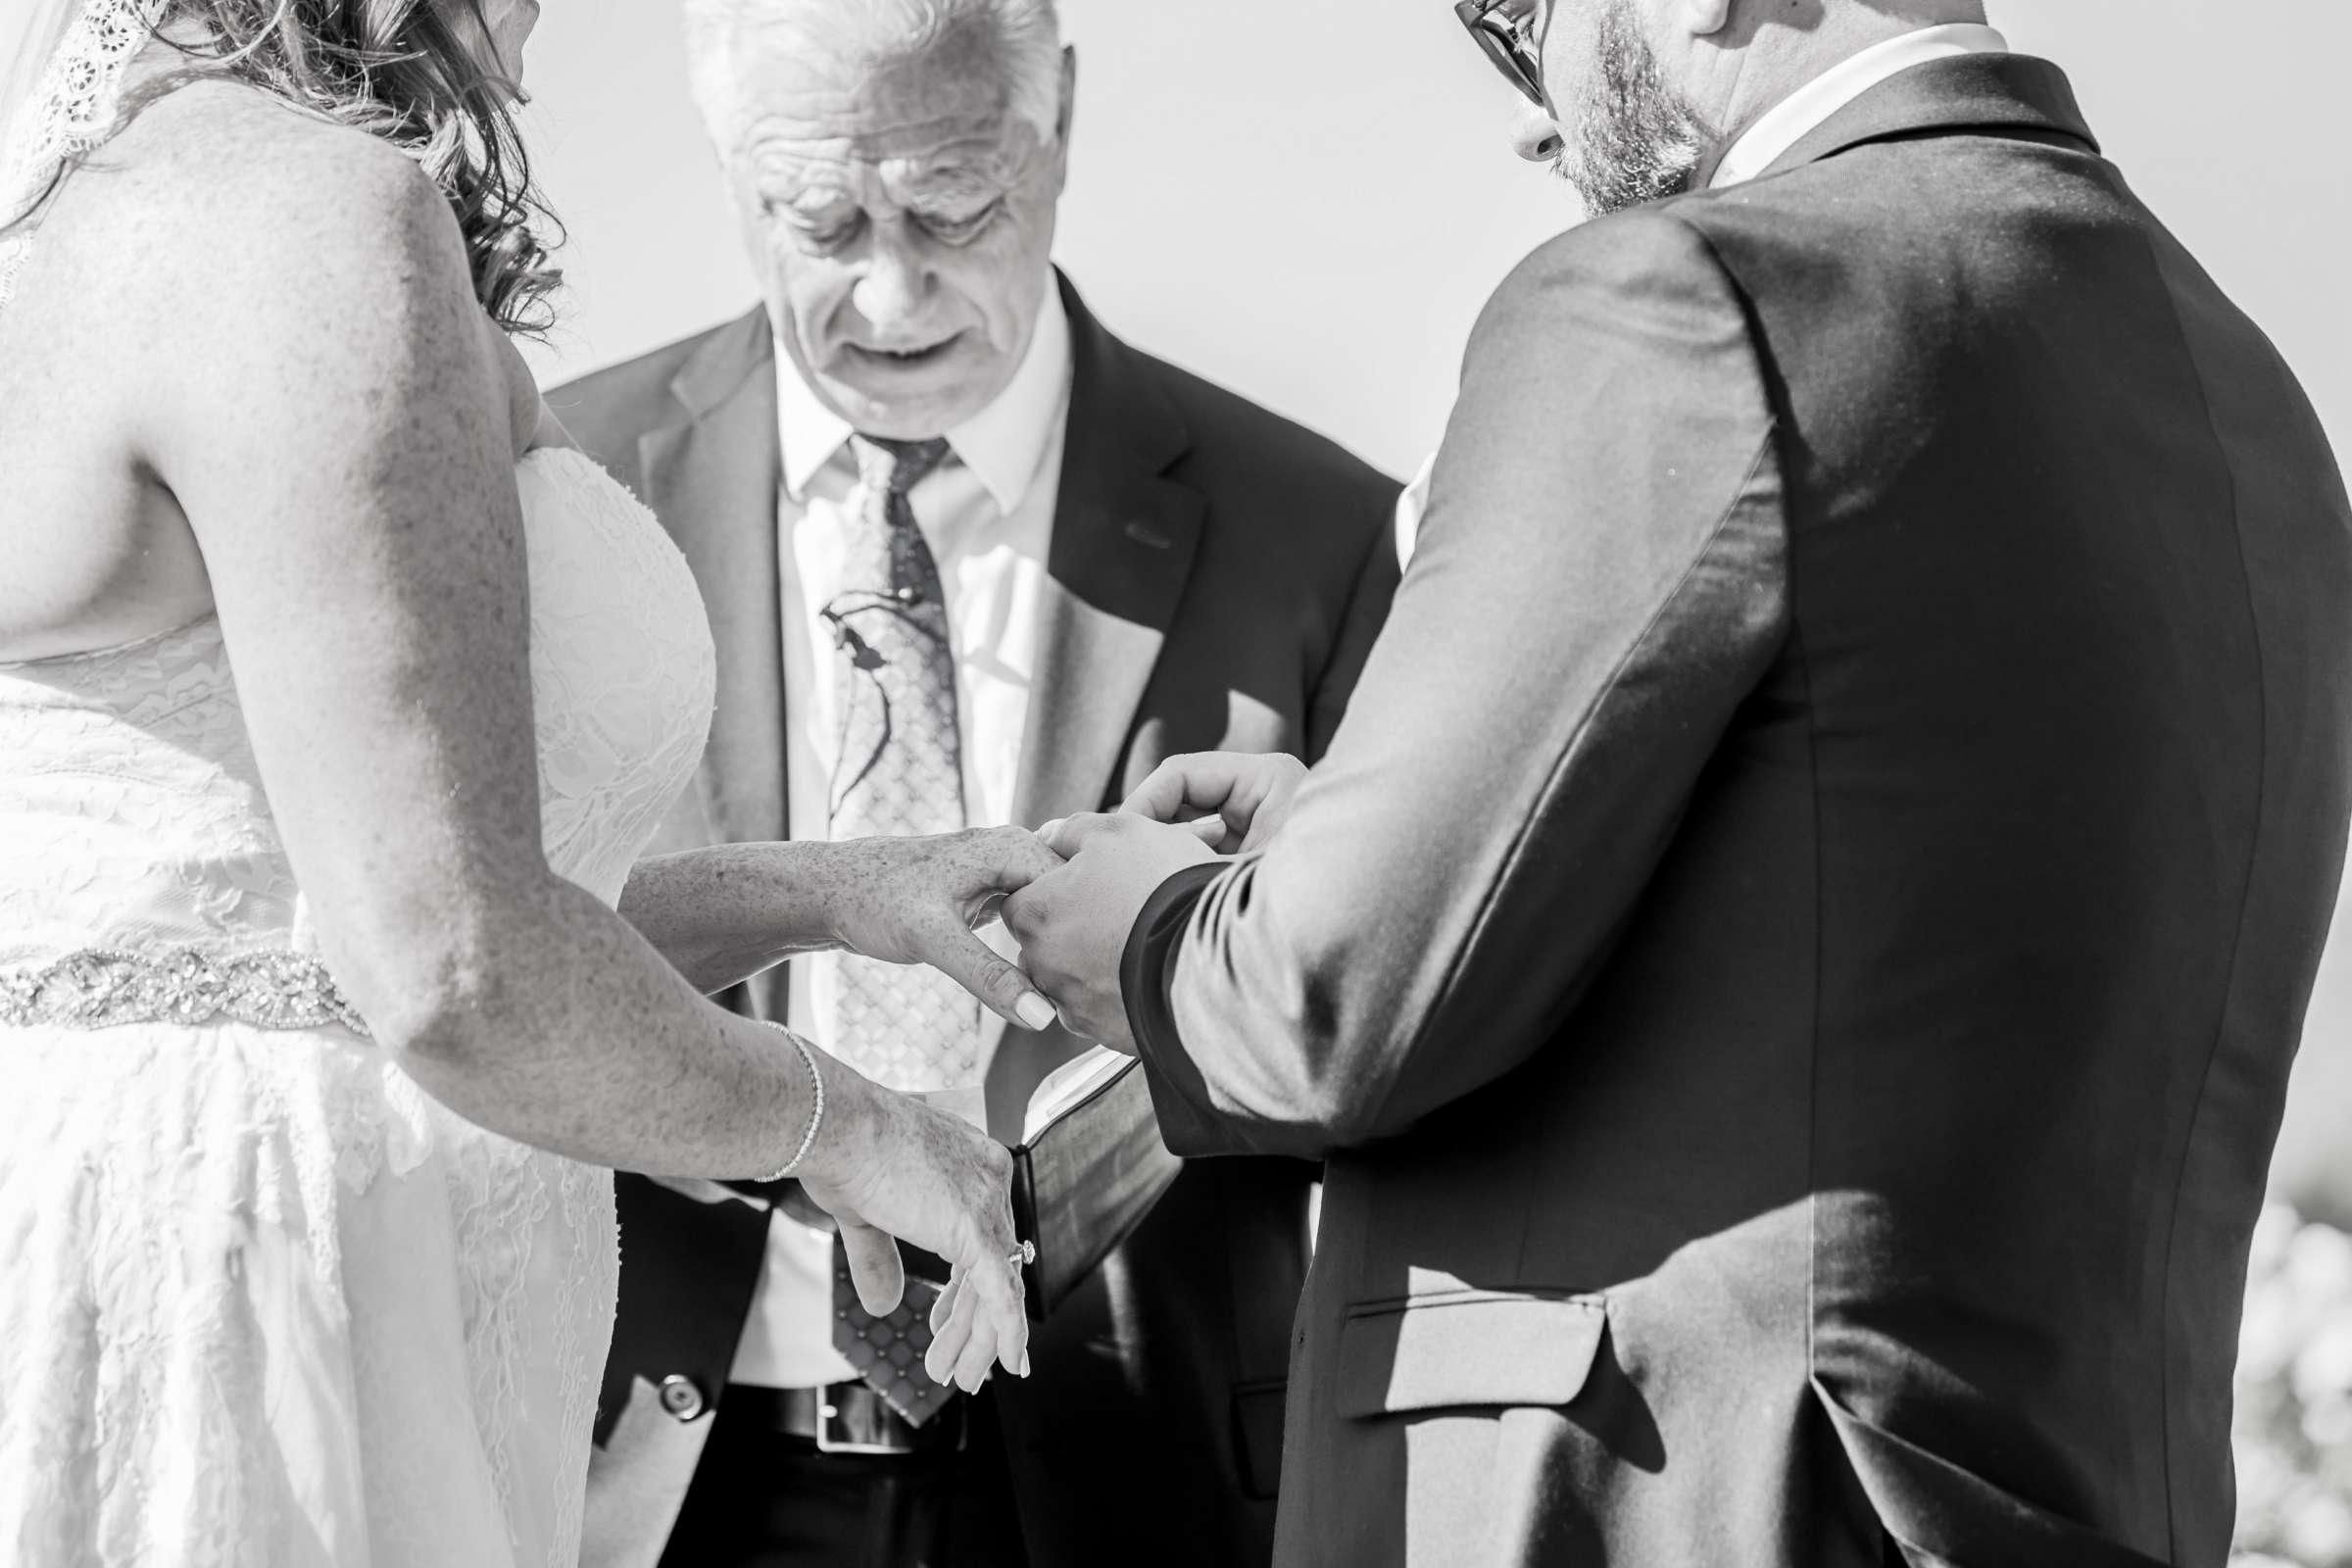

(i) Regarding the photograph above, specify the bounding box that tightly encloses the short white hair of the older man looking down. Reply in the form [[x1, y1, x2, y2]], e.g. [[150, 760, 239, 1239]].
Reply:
[[684, 0, 1060, 153]]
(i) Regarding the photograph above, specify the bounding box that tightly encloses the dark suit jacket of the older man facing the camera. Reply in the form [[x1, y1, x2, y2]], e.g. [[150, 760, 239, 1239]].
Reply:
[[548, 282, 1397, 1568]]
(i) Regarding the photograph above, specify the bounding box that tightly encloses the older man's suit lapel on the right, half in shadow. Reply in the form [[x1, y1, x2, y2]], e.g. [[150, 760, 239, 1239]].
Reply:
[[1013, 279, 1209, 827]]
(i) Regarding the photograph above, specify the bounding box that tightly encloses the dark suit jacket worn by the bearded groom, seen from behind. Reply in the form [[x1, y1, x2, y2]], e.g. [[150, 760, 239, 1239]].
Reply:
[[1127, 57, 2352, 1568]]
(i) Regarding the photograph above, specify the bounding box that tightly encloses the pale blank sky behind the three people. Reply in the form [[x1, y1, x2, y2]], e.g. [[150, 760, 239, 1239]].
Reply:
[[510, 0, 2352, 1210]]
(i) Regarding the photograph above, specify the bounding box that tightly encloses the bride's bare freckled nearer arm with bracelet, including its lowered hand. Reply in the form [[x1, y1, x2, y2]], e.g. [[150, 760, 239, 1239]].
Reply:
[[124, 111, 1025, 1373]]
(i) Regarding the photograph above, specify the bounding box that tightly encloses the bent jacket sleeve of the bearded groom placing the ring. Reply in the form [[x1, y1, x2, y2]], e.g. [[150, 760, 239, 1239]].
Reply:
[[1127, 212, 1788, 1156]]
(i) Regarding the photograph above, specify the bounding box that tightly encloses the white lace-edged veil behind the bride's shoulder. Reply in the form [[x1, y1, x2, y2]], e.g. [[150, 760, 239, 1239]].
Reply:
[[0, 0, 167, 306]]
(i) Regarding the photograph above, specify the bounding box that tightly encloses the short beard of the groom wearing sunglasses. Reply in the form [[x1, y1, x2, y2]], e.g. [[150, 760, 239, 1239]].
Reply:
[[1552, 0, 1717, 217]]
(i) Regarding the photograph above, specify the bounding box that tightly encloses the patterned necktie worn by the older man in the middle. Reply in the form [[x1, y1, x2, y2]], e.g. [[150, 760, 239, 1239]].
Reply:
[[825, 435, 986, 1427]]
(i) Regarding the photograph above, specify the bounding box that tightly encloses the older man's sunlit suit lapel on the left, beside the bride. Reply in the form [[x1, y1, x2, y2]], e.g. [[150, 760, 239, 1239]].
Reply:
[[640, 311, 786, 859]]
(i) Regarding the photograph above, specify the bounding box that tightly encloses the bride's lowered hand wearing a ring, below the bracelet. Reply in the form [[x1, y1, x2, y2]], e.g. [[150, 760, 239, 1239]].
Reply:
[[800, 1060, 1028, 1394]]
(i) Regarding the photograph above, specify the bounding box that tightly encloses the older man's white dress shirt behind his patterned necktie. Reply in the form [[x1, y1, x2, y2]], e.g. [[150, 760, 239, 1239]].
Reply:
[[731, 282, 1070, 1390]]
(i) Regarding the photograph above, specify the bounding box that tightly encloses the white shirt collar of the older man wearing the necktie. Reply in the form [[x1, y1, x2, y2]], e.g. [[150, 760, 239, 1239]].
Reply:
[[776, 279, 1070, 513]]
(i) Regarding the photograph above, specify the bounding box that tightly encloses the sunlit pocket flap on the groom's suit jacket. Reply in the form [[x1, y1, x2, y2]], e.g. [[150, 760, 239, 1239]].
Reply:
[[1339, 1291, 1609, 1417]]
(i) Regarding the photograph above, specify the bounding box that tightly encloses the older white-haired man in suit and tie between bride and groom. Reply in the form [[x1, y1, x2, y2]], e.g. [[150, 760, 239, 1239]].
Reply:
[[553, 0, 1397, 1568]]
